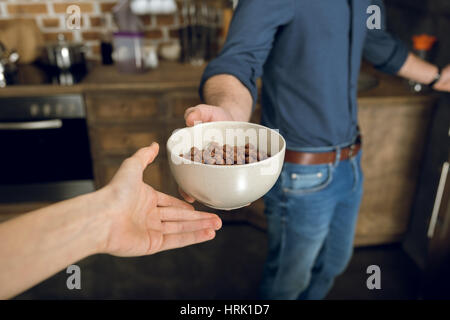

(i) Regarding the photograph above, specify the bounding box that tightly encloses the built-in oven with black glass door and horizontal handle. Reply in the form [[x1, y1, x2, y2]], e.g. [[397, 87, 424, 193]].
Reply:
[[0, 94, 94, 203]]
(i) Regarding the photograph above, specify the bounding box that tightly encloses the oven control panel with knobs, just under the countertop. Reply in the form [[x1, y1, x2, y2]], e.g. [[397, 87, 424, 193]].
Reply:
[[0, 94, 86, 120]]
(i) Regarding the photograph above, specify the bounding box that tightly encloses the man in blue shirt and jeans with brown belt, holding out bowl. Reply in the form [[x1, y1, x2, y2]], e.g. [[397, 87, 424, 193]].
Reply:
[[185, 0, 450, 299]]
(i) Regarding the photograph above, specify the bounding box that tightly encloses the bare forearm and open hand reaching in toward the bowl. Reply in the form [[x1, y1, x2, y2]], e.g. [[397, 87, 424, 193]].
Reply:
[[0, 143, 222, 299]]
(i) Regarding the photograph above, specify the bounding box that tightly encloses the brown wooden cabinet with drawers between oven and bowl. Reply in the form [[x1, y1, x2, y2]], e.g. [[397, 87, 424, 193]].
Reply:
[[86, 87, 200, 195]]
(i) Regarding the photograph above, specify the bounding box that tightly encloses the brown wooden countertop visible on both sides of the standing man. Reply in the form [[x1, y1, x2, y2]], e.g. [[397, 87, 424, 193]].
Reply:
[[0, 61, 436, 102]]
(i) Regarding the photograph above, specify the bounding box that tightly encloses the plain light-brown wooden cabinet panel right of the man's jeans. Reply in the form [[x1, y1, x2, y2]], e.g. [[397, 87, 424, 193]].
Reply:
[[356, 97, 434, 245]]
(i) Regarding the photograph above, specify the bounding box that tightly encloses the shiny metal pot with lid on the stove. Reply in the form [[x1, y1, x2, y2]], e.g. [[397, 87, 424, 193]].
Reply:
[[46, 34, 86, 70]]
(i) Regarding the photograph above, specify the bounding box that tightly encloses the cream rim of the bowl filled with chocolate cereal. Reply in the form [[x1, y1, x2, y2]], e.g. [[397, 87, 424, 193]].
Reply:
[[166, 121, 286, 169]]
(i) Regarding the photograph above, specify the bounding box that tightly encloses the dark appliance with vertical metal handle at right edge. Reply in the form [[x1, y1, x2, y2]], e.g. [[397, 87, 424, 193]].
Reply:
[[403, 94, 450, 299]]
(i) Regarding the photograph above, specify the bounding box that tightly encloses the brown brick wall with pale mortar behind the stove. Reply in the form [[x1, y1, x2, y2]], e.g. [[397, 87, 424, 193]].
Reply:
[[0, 0, 221, 58]]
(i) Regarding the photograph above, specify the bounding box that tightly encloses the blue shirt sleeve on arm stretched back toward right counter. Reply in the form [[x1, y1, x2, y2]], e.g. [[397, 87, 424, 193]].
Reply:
[[363, 0, 409, 74]]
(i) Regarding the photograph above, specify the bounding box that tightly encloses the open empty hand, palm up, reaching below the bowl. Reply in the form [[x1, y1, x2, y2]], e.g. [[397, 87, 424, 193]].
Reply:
[[100, 143, 222, 256]]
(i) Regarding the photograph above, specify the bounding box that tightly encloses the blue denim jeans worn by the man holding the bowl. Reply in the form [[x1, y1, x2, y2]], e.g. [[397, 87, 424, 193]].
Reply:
[[261, 151, 363, 299]]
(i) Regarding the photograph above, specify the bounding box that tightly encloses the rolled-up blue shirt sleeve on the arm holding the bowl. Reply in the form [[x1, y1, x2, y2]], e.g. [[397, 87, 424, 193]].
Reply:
[[199, 0, 294, 106]]
